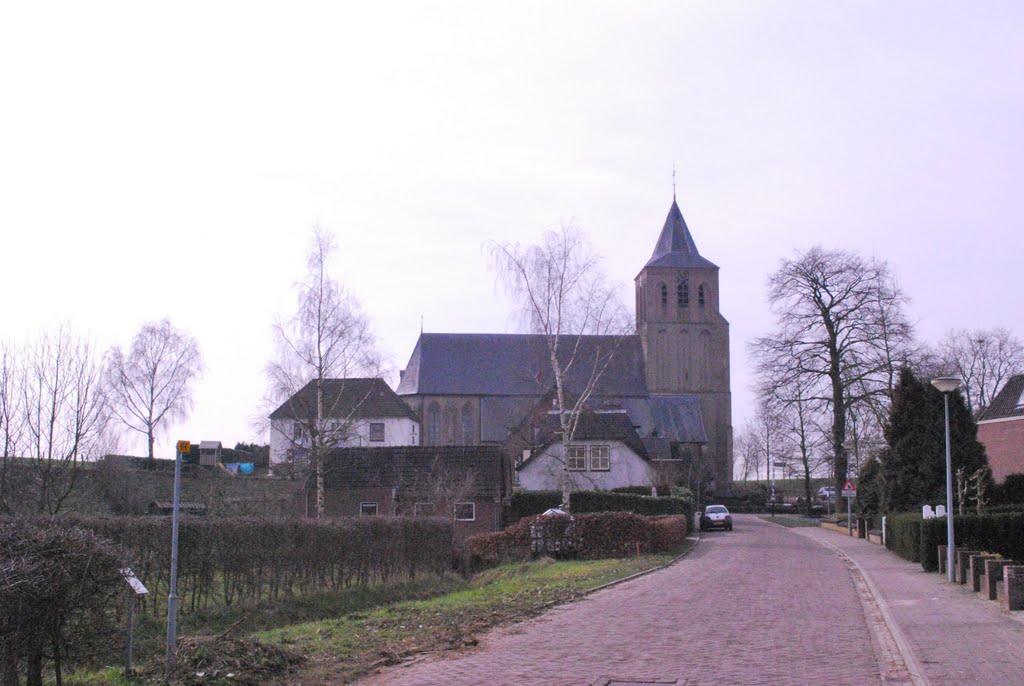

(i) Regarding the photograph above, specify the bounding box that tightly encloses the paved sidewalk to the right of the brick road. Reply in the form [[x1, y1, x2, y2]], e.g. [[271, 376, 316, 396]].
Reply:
[[791, 528, 1024, 686]]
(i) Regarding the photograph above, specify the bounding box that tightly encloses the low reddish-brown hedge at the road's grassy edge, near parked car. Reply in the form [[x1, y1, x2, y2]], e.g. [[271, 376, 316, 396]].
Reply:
[[466, 512, 689, 568]]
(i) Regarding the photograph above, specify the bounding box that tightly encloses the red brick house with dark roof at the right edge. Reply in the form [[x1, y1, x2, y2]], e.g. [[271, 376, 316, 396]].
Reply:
[[978, 374, 1024, 482]]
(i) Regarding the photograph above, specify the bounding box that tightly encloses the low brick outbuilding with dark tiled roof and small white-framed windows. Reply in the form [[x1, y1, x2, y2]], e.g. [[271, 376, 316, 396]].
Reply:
[[304, 445, 511, 543]]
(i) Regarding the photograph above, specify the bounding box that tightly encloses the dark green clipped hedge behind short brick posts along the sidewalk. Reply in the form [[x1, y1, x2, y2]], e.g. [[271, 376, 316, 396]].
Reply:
[[886, 512, 1024, 571]]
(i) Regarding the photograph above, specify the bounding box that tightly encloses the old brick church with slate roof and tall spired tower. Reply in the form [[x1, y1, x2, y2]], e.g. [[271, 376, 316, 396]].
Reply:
[[397, 199, 732, 490]]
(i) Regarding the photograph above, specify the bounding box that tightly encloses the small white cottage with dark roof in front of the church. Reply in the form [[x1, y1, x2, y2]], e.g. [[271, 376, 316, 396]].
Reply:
[[516, 412, 656, 490]]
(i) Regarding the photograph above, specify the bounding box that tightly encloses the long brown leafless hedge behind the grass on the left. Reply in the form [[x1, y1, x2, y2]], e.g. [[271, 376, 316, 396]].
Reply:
[[9, 517, 452, 612]]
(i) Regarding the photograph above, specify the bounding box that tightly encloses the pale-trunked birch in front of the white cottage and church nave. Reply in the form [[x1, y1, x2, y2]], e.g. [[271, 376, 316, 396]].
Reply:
[[487, 226, 630, 508]]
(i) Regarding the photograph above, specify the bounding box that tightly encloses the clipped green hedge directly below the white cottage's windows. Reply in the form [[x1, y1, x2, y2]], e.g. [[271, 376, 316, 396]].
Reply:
[[509, 490, 693, 521]]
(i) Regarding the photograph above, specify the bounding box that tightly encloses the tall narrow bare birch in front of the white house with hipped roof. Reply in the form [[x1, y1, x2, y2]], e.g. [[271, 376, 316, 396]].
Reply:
[[266, 227, 382, 518]]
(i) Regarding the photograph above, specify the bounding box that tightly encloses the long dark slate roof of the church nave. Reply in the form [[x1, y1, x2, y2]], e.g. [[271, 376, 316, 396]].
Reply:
[[397, 334, 647, 397]]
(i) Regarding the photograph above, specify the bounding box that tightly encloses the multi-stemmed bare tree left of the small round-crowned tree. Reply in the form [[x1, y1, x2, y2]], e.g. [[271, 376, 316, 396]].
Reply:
[[20, 327, 108, 514]]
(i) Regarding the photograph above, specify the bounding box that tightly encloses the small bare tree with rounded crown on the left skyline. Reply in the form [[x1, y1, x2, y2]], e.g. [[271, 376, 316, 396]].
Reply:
[[103, 319, 203, 460]]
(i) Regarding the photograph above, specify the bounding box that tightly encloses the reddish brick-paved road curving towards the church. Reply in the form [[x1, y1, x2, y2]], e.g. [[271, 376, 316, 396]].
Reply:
[[359, 516, 882, 686]]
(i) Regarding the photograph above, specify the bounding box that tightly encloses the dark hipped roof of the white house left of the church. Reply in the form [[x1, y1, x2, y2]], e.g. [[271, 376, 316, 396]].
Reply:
[[270, 379, 419, 421]]
